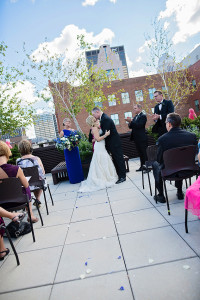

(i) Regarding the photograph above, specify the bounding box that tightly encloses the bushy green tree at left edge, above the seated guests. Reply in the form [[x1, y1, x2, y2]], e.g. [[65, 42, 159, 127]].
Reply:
[[0, 42, 33, 136]]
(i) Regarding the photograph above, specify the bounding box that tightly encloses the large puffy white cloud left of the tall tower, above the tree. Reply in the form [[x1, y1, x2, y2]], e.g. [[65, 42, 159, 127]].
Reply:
[[32, 24, 115, 60]]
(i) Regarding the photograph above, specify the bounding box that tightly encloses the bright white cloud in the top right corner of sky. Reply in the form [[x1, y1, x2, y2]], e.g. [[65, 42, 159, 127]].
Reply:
[[158, 0, 200, 44]]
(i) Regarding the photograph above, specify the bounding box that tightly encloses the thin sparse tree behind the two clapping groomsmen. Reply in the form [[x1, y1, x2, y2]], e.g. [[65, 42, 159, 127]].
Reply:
[[143, 20, 197, 111]]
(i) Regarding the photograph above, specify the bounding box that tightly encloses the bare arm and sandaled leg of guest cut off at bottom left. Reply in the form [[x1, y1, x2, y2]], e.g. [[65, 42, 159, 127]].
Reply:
[[0, 207, 25, 260]]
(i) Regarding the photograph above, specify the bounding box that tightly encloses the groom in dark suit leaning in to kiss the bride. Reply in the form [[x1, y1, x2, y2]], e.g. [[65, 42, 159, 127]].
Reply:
[[92, 107, 126, 183]]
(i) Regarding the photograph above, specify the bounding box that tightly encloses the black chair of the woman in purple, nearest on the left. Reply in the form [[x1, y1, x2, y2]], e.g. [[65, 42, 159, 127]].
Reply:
[[0, 177, 35, 242]]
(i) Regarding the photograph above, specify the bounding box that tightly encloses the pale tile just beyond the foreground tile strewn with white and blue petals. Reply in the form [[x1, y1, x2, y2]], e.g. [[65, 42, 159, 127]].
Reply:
[[66, 217, 116, 247]]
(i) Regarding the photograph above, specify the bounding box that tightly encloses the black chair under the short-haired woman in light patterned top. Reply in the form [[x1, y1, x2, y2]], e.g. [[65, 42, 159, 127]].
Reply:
[[22, 166, 54, 217]]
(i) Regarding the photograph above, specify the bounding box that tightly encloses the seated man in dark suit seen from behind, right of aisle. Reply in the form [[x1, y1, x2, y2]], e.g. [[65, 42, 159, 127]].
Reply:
[[153, 113, 197, 203]]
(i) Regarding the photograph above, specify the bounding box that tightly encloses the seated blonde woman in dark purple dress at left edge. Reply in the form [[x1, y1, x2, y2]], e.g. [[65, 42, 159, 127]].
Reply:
[[0, 141, 38, 223]]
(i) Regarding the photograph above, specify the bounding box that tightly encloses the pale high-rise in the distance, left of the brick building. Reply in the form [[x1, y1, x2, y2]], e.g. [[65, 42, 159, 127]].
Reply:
[[34, 113, 58, 140]]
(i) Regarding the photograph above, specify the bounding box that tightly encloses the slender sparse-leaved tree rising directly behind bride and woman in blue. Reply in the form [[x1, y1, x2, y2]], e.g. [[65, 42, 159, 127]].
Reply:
[[24, 35, 122, 132]]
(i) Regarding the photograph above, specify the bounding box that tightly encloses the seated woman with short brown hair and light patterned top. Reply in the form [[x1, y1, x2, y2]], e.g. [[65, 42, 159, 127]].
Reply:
[[16, 140, 46, 206]]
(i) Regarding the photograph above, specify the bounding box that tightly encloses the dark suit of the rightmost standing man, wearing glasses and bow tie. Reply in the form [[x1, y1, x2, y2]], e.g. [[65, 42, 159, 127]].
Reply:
[[152, 99, 174, 136]]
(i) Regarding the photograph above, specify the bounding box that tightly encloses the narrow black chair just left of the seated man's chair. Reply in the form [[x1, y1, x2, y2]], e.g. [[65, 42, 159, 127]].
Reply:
[[142, 145, 158, 196]]
